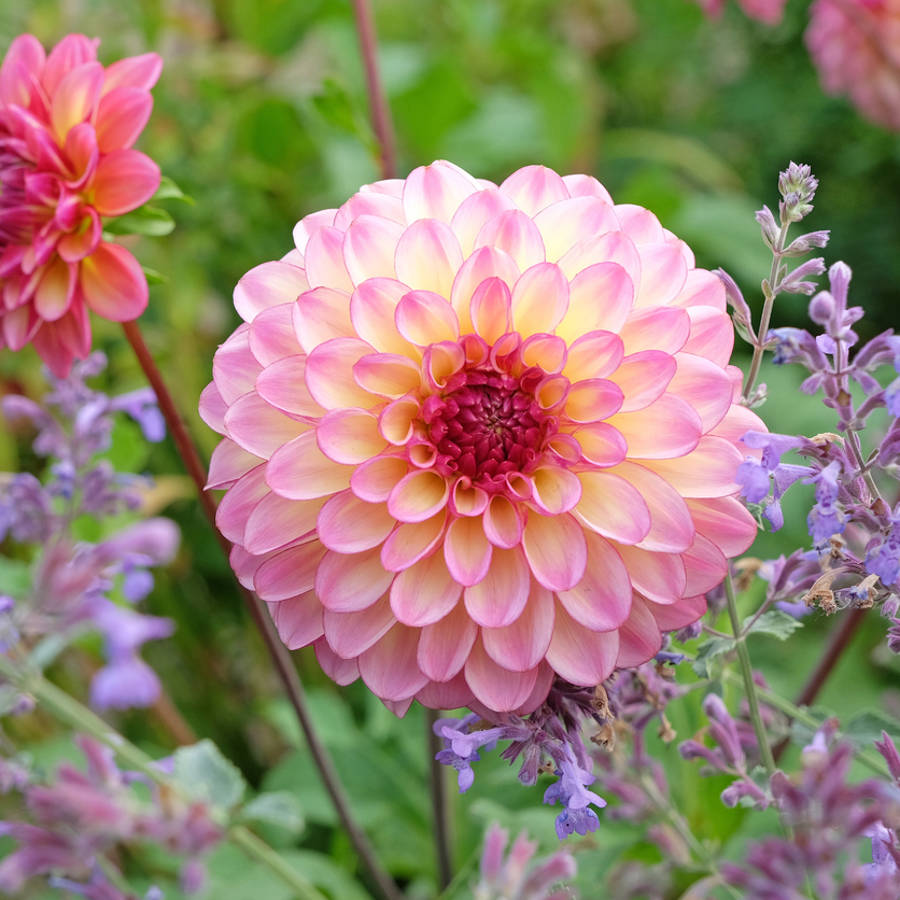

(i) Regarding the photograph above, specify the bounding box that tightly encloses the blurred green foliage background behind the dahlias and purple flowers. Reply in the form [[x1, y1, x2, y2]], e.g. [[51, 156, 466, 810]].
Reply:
[[0, 0, 900, 900]]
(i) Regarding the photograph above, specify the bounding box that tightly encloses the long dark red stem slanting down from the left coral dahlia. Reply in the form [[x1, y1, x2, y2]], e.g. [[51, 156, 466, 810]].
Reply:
[[123, 322, 402, 900]]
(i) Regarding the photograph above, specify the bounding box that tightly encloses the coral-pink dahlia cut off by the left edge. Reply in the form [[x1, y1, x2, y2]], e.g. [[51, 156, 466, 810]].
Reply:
[[0, 34, 162, 377]]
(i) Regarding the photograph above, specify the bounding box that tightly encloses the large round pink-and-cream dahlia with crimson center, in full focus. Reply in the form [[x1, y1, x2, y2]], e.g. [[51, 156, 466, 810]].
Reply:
[[200, 162, 763, 711]]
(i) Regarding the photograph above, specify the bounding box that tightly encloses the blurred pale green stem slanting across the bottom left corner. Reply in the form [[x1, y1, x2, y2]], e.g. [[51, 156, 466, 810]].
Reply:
[[0, 655, 325, 900]]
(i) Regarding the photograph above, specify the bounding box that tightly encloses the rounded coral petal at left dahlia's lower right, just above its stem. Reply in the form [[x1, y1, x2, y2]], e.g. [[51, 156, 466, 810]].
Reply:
[[80, 242, 148, 322]]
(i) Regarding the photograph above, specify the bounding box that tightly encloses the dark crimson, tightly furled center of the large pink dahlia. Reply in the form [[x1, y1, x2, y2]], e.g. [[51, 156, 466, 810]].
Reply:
[[424, 350, 557, 496]]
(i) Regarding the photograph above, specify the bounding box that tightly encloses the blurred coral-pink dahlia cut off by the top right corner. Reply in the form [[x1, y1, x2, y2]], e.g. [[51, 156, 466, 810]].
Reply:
[[806, 0, 900, 131]]
